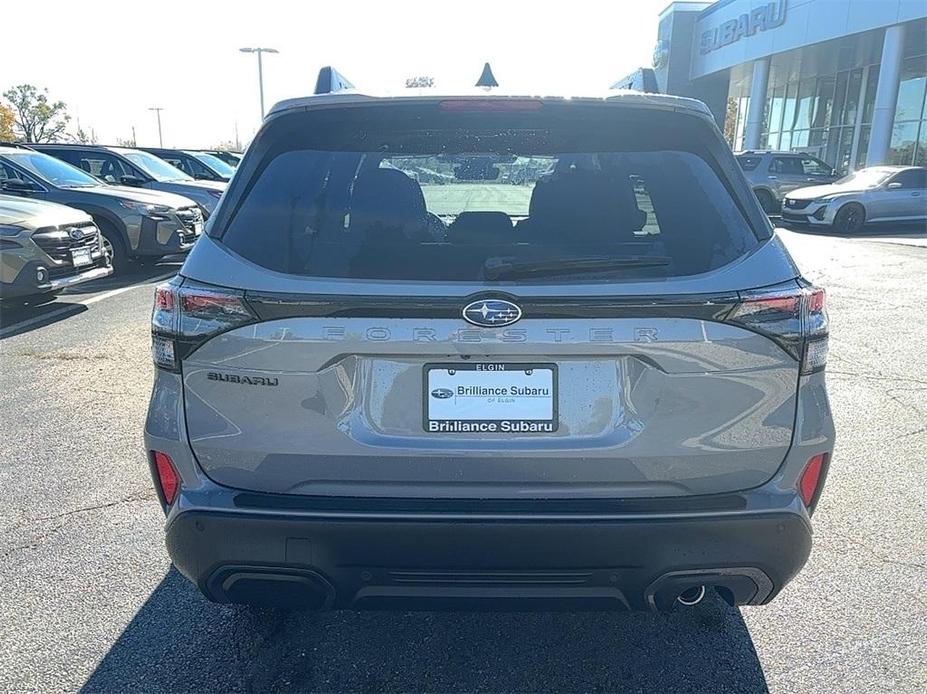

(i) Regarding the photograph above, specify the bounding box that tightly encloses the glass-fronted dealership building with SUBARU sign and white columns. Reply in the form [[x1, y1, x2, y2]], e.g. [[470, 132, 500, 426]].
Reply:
[[636, 0, 927, 170]]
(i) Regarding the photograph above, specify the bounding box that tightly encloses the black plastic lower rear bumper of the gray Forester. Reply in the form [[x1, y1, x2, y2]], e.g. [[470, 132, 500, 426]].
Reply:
[[167, 502, 811, 609]]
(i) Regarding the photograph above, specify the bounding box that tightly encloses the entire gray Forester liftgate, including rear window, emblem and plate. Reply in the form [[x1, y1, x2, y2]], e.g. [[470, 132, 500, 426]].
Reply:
[[167, 97, 806, 498]]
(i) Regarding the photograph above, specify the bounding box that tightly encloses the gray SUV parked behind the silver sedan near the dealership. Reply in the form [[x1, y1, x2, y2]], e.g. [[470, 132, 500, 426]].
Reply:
[[735, 151, 840, 214]]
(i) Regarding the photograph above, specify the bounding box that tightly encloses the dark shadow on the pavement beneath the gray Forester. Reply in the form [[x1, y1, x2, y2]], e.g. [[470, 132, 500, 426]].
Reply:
[[83, 569, 767, 692]]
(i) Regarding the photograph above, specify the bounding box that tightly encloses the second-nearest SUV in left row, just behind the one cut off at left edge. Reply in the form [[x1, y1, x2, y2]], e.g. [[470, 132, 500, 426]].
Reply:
[[0, 147, 203, 273]]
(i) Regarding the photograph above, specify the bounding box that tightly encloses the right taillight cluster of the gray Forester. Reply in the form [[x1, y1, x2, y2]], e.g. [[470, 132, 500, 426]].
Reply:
[[726, 283, 827, 374]]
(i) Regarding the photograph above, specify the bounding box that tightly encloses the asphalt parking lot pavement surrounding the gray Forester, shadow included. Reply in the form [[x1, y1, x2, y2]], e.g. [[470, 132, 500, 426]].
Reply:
[[0, 233, 927, 694]]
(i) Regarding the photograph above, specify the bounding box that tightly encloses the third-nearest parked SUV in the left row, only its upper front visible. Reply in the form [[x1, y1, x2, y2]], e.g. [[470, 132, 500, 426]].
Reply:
[[29, 143, 225, 218]]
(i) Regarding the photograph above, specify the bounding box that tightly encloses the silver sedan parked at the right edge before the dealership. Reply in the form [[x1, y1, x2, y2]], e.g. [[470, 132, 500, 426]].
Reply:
[[782, 166, 927, 234]]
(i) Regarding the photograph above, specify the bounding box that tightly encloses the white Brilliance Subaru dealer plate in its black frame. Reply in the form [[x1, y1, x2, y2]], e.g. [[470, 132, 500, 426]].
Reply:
[[423, 363, 559, 434]]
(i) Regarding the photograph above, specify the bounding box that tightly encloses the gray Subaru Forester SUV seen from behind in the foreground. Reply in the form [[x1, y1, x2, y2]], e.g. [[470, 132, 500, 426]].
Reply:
[[145, 92, 834, 609]]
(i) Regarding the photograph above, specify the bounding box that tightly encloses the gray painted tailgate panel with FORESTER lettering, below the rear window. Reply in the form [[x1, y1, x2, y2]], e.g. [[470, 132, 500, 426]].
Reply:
[[183, 290, 798, 498]]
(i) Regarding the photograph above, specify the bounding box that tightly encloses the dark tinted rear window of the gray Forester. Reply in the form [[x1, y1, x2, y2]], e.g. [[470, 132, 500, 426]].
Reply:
[[221, 108, 757, 282]]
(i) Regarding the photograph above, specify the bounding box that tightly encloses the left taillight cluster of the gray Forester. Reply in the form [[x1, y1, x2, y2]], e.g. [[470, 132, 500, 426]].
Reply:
[[151, 277, 255, 371]]
